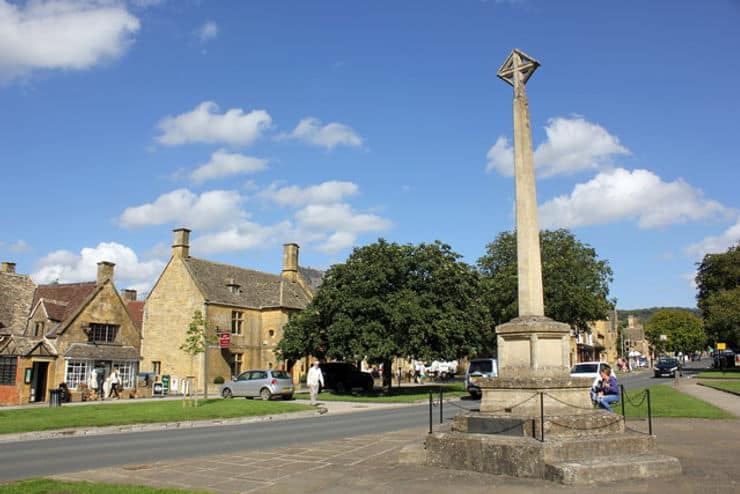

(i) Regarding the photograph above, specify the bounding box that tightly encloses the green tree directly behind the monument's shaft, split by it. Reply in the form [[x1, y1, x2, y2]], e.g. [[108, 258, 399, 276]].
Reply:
[[478, 230, 614, 331]]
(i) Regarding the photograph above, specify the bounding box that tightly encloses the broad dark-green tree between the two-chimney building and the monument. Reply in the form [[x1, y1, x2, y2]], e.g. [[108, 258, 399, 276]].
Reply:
[[278, 239, 490, 385]]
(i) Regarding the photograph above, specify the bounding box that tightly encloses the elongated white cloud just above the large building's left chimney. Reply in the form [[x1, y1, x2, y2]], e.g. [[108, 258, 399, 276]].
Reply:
[[118, 189, 245, 229]]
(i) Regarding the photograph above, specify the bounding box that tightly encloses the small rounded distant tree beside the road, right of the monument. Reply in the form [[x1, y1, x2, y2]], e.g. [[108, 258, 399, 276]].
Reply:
[[645, 309, 707, 354]]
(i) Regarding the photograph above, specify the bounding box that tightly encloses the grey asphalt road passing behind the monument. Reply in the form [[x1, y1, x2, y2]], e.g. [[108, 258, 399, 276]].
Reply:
[[0, 362, 708, 482]]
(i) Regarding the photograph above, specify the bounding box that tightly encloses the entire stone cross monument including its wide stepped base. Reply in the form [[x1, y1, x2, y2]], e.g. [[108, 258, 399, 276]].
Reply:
[[408, 49, 681, 484]]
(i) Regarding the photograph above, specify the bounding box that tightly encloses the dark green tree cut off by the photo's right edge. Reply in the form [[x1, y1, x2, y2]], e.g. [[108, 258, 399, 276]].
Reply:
[[696, 243, 740, 348]]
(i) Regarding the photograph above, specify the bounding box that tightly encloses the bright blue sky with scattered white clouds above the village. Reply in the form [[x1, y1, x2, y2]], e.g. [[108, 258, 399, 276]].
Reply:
[[0, 0, 740, 309]]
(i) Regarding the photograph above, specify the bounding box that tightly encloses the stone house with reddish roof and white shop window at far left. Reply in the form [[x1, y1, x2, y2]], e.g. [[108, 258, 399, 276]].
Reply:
[[0, 261, 141, 403]]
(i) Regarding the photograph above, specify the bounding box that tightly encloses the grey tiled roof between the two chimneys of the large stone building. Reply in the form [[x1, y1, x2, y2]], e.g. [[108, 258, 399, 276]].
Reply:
[[183, 257, 309, 309]]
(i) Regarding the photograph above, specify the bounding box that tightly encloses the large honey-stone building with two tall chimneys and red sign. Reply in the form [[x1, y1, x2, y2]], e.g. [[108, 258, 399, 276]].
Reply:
[[142, 228, 321, 390]]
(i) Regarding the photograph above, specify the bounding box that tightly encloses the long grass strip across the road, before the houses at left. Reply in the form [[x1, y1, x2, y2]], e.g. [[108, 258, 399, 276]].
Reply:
[[0, 398, 313, 434]]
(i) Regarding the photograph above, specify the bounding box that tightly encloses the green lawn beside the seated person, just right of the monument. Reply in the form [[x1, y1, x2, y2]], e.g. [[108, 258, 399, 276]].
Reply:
[[613, 384, 735, 419]]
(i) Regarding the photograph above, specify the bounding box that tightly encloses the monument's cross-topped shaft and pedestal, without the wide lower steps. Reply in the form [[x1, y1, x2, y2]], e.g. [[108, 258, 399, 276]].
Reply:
[[481, 49, 589, 415]]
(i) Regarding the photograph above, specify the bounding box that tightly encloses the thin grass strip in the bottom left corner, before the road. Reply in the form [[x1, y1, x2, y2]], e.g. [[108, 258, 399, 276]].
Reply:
[[0, 479, 205, 494]]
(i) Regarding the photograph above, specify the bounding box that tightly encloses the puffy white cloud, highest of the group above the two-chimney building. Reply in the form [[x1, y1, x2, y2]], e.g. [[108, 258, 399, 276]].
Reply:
[[157, 101, 272, 146]]
